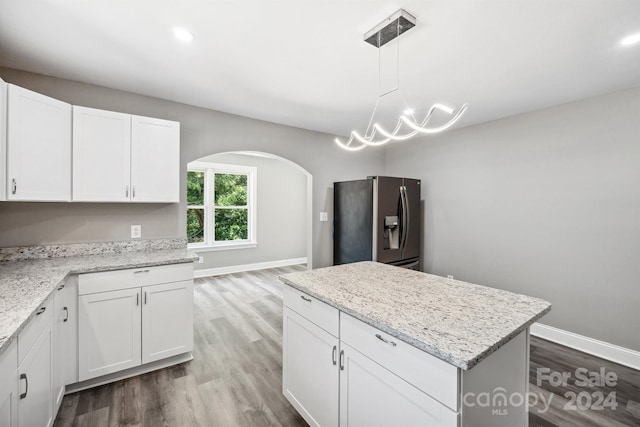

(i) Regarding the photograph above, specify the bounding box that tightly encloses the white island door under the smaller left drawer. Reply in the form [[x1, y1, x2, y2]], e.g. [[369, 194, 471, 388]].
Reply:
[[282, 306, 339, 427]]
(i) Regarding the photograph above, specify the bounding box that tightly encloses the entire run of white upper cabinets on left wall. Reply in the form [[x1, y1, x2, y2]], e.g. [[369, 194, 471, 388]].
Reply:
[[0, 85, 180, 203]]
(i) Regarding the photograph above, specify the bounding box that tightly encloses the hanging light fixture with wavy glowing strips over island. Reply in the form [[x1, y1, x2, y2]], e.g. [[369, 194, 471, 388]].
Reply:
[[335, 9, 468, 151]]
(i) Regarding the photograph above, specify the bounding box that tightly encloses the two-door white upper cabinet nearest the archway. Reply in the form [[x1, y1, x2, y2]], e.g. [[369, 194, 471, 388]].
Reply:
[[73, 110, 180, 203]]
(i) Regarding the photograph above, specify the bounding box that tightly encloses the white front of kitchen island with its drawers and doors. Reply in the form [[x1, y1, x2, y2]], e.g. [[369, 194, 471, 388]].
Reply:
[[282, 286, 458, 427]]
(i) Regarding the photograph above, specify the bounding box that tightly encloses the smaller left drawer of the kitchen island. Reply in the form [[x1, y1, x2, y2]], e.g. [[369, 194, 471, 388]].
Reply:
[[282, 285, 340, 337]]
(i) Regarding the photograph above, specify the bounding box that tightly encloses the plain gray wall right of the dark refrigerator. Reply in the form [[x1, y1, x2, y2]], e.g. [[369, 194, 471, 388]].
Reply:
[[385, 88, 640, 350]]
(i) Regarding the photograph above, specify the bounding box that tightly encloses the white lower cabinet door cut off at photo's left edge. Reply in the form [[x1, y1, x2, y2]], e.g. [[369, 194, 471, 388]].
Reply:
[[0, 341, 18, 427]]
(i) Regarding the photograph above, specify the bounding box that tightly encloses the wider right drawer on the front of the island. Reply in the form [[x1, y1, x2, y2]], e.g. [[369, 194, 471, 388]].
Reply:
[[340, 313, 458, 412]]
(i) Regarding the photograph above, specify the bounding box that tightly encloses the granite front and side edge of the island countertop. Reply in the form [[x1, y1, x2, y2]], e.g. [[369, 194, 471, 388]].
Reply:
[[280, 276, 551, 370]]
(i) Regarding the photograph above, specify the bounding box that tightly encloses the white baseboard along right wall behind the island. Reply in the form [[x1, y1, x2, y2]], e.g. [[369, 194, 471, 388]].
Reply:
[[530, 323, 640, 369]]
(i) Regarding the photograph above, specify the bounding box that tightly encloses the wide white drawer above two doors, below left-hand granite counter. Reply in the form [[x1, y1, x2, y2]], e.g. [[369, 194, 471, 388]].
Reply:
[[78, 263, 193, 295]]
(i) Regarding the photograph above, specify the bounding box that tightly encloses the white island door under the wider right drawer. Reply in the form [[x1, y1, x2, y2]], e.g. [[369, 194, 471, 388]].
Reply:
[[340, 342, 458, 427]]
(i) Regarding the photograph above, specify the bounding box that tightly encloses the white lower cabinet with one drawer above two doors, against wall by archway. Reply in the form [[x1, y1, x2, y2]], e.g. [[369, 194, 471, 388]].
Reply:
[[78, 264, 193, 381]]
